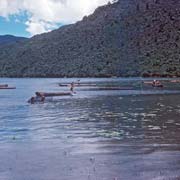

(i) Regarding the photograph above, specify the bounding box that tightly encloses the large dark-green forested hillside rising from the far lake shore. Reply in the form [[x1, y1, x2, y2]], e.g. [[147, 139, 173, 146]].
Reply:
[[0, 0, 180, 77]]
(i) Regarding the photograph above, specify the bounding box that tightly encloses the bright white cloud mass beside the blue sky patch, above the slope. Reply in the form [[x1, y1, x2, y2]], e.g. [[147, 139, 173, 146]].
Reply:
[[0, 0, 112, 36]]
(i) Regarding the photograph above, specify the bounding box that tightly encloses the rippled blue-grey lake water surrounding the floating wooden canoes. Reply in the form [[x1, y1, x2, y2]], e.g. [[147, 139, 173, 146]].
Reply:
[[0, 78, 180, 180]]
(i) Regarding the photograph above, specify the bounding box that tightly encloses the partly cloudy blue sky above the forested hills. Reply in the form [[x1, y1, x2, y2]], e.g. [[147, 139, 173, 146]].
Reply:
[[0, 0, 110, 37]]
